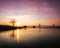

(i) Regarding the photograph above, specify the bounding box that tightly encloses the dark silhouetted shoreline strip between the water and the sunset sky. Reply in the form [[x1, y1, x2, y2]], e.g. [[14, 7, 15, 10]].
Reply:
[[0, 25, 60, 31]]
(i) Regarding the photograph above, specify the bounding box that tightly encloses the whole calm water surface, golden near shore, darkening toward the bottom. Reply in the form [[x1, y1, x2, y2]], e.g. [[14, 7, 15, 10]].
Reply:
[[0, 28, 60, 47]]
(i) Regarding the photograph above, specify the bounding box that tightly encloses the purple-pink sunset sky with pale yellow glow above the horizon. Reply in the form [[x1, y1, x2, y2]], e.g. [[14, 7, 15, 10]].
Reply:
[[0, 0, 60, 26]]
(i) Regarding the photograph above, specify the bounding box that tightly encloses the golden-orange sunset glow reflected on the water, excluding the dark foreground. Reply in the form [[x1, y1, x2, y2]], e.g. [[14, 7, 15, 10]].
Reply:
[[0, 28, 60, 44]]
